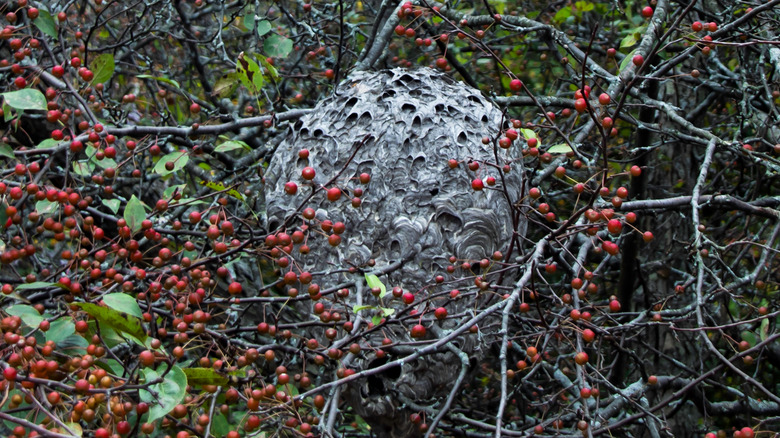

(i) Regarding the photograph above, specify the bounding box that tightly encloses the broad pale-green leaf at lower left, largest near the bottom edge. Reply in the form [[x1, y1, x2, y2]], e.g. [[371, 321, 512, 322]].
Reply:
[[138, 365, 187, 423]]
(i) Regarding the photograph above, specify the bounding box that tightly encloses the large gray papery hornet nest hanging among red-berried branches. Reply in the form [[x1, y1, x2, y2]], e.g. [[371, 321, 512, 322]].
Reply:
[[265, 68, 524, 436]]
